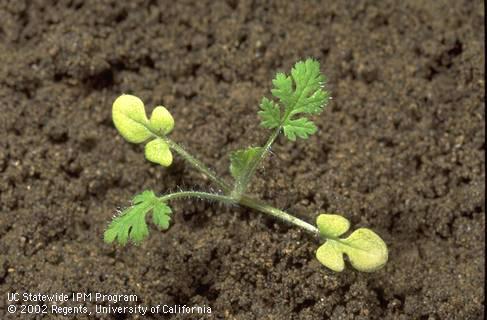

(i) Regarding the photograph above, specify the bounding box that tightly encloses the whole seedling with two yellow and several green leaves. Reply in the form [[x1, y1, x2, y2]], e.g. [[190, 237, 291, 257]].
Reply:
[[104, 59, 388, 272]]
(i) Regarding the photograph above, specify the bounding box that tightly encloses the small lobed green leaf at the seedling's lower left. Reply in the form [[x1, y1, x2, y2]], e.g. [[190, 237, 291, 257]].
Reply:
[[104, 191, 171, 245]]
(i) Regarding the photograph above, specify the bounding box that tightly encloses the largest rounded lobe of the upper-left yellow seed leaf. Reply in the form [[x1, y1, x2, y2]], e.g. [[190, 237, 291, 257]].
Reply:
[[112, 94, 152, 143]]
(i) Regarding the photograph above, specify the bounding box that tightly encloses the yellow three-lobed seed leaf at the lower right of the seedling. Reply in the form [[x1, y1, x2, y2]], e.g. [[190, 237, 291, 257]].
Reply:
[[316, 214, 388, 272]]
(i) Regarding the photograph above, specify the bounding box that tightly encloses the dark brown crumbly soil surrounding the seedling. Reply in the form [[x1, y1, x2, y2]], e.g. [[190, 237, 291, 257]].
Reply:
[[0, 0, 485, 319]]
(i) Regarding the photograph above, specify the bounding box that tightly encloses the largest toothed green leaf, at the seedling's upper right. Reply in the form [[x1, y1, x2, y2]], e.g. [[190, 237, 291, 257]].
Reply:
[[259, 59, 330, 141]]
